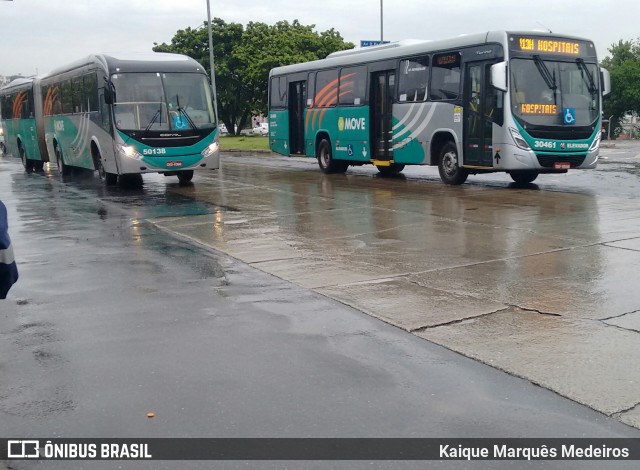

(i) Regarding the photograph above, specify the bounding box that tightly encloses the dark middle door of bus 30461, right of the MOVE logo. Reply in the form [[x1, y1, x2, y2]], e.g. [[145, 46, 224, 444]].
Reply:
[[369, 70, 396, 160]]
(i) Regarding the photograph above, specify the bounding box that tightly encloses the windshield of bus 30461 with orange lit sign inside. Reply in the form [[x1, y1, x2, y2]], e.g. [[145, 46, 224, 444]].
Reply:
[[511, 55, 600, 126]]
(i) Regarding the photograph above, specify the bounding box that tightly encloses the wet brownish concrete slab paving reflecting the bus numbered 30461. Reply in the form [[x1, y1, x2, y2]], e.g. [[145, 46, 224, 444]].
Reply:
[[152, 157, 640, 427]]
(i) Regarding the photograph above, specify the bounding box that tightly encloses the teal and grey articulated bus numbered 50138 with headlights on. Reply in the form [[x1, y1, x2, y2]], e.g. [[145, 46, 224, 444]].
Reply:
[[0, 53, 220, 185]]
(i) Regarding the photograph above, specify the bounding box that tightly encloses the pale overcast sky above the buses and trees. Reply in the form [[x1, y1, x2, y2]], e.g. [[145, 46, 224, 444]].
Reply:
[[0, 0, 640, 75]]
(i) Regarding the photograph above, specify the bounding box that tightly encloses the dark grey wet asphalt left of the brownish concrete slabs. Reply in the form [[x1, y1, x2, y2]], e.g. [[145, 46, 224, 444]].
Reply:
[[0, 145, 640, 469]]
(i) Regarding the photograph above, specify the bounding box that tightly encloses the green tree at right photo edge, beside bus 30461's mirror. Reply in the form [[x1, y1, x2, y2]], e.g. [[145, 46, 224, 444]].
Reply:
[[601, 40, 640, 134]]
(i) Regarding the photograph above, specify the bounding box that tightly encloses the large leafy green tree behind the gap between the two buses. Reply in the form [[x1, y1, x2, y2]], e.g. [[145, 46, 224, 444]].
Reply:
[[153, 18, 354, 132]]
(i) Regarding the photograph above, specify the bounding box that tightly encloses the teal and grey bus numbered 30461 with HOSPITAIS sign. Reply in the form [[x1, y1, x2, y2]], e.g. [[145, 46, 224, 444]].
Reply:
[[269, 31, 610, 184]]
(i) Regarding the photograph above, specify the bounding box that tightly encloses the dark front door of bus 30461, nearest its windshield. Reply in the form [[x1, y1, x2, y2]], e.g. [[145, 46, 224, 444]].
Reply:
[[463, 62, 498, 167]]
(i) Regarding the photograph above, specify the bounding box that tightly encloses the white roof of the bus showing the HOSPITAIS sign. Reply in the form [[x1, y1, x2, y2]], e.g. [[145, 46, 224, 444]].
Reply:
[[270, 31, 585, 76]]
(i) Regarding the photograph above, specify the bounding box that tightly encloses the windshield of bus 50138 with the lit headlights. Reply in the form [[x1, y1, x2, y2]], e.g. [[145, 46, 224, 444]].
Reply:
[[111, 72, 215, 131]]
